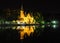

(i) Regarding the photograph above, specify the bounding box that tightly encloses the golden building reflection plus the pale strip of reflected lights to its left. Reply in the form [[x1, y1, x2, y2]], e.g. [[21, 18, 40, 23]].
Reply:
[[0, 26, 40, 39]]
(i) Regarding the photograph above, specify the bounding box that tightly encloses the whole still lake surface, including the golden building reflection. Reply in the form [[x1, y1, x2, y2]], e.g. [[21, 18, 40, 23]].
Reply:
[[0, 26, 60, 43]]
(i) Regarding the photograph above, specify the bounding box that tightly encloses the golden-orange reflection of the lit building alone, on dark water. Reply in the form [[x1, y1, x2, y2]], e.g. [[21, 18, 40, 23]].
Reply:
[[16, 26, 35, 39]]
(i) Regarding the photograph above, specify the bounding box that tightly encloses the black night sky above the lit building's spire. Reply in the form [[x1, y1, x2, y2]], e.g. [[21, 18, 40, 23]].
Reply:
[[0, 0, 60, 13]]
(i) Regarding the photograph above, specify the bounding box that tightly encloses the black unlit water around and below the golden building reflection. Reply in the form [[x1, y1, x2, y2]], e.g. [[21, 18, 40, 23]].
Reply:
[[0, 27, 60, 43]]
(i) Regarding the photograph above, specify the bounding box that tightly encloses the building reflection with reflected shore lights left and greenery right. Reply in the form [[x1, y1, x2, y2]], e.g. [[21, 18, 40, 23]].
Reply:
[[0, 25, 42, 39]]
